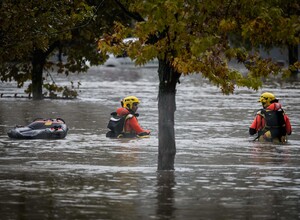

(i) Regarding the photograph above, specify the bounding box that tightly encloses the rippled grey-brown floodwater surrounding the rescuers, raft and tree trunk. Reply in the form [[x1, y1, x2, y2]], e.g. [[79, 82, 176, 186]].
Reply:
[[0, 67, 300, 220]]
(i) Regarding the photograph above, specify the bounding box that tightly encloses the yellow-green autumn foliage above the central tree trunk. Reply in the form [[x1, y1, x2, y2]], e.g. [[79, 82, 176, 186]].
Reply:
[[99, 0, 300, 94]]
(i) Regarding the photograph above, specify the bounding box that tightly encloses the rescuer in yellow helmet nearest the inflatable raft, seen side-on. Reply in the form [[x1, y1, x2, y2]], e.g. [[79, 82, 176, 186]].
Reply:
[[106, 96, 150, 137]]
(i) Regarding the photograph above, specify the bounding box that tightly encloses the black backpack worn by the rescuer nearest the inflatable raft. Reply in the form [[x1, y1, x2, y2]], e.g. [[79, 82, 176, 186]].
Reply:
[[106, 112, 127, 137]]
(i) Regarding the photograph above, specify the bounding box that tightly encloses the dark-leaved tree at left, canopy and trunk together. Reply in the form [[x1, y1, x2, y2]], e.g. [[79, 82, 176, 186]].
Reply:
[[0, 0, 128, 99]]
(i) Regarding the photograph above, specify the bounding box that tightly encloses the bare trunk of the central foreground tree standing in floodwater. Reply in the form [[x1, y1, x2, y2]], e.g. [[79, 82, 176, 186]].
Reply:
[[158, 60, 180, 170]]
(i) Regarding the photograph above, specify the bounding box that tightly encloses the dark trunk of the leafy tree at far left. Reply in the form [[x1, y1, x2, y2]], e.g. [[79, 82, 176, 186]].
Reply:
[[31, 50, 47, 100]]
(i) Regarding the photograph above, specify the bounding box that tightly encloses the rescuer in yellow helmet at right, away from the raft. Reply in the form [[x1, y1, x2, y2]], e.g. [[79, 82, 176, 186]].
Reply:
[[249, 92, 292, 143]]
